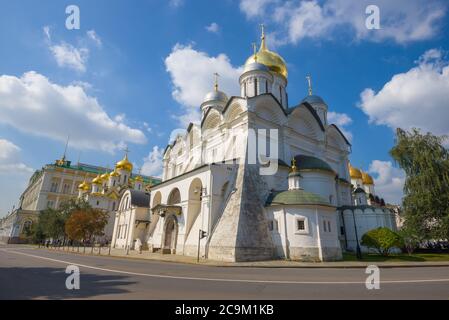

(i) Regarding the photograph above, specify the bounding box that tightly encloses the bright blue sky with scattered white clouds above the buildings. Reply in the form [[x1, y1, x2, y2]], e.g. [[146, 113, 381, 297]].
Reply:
[[0, 0, 449, 216]]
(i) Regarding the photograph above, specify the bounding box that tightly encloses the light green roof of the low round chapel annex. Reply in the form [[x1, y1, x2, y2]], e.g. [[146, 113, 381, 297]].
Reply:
[[267, 189, 331, 206]]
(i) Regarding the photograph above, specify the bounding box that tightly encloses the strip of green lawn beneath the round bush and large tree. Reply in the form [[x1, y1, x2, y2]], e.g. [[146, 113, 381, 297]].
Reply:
[[343, 252, 449, 262]]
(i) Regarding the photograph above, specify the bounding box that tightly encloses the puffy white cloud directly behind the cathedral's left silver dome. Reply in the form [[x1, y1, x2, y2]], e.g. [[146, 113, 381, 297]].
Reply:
[[165, 44, 241, 125]]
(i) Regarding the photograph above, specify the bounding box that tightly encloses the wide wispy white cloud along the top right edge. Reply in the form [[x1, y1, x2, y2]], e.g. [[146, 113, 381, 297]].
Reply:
[[240, 0, 447, 45]]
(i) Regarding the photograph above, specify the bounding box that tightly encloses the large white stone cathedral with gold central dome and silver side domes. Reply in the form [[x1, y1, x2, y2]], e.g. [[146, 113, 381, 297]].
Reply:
[[112, 31, 395, 262]]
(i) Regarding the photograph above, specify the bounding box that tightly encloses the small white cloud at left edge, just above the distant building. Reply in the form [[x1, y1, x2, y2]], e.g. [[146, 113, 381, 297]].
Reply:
[[0, 139, 33, 175]]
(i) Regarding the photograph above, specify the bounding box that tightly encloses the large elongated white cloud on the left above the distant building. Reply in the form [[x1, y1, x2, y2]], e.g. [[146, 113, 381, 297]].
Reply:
[[0, 71, 146, 153]]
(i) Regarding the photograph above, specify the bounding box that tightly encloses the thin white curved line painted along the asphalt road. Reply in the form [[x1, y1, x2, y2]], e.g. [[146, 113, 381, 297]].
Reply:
[[0, 249, 449, 285]]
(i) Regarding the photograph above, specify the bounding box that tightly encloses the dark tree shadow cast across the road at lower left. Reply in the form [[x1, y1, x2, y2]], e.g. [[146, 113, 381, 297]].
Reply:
[[0, 267, 135, 300]]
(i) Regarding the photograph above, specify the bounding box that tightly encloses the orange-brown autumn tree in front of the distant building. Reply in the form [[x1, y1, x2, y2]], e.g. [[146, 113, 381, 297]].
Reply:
[[65, 208, 108, 241]]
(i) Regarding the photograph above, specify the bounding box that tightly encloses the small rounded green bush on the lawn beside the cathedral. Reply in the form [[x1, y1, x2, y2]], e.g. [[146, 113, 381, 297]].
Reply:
[[361, 228, 404, 256]]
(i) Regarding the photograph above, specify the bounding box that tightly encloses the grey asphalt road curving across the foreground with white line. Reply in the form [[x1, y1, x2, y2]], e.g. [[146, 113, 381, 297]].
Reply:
[[0, 246, 449, 300]]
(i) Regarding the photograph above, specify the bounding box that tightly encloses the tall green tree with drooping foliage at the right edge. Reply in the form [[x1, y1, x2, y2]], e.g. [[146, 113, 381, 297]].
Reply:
[[390, 129, 449, 239]]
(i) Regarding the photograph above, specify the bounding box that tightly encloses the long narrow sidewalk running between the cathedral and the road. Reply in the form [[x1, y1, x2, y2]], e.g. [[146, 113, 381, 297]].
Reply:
[[29, 246, 449, 268]]
